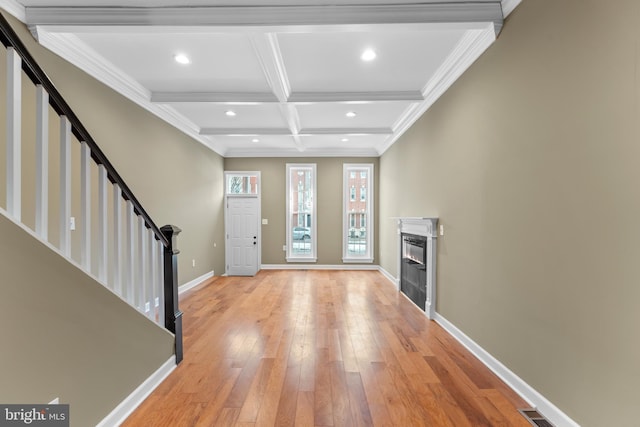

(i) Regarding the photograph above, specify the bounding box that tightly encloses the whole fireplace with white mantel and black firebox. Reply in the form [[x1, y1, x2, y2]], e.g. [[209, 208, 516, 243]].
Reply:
[[398, 218, 438, 318]]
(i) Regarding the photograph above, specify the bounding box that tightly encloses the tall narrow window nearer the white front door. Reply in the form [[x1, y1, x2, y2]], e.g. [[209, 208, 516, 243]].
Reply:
[[287, 163, 318, 262]]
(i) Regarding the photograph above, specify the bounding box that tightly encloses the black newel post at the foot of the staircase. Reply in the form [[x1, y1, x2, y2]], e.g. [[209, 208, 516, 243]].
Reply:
[[160, 225, 183, 363]]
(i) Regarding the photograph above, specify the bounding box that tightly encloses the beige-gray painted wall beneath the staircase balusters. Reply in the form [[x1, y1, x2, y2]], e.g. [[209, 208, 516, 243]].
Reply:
[[0, 215, 174, 426]]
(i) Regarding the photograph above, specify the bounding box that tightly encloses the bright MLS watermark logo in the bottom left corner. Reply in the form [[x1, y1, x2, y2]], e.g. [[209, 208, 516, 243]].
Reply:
[[0, 404, 69, 427]]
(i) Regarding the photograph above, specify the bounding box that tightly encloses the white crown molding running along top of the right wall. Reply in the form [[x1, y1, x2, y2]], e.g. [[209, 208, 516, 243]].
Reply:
[[379, 23, 496, 155]]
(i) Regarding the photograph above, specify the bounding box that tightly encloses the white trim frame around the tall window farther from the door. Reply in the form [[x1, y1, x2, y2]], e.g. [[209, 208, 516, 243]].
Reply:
[[342, 163, 375, 263]]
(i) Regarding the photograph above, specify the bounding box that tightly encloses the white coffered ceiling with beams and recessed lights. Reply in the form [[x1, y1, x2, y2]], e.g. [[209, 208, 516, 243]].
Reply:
[[3, 0, 520, 157]]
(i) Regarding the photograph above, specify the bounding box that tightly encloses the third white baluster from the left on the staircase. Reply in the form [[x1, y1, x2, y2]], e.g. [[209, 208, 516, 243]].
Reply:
[[60, 116, 71, 257]]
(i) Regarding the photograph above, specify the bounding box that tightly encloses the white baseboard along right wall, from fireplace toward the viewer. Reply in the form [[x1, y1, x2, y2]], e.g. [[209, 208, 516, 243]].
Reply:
[[434, 313, 580, 427]]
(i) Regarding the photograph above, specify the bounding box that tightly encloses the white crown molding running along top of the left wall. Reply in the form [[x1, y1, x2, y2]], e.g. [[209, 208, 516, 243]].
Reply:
[[29, 26, 223, 155]]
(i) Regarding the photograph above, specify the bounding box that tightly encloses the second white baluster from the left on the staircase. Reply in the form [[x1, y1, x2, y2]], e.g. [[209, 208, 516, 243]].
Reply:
[[36, 85, 49, 241]]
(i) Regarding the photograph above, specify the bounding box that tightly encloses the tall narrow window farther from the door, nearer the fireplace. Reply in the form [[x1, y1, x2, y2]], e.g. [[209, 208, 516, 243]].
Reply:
[[342, 163, 374, 262]]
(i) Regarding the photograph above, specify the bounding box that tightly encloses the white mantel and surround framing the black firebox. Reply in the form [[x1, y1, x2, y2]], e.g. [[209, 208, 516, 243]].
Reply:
[[395, 217, 438, 319]]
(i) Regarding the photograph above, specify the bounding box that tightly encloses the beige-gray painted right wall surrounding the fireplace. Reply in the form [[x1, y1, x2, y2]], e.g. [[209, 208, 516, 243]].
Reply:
[[379, 0, 640, 427]]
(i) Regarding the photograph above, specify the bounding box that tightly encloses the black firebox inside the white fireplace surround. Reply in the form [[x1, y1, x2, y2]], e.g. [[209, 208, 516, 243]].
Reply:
[[400, 233, 427, 310]]
